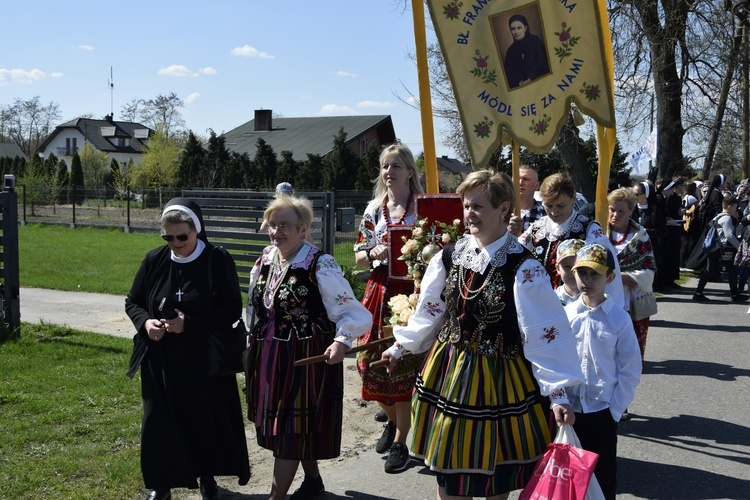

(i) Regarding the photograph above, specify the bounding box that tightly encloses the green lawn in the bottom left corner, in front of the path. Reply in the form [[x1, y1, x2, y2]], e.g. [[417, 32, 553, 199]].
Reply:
[[0, 324, 143, 499]]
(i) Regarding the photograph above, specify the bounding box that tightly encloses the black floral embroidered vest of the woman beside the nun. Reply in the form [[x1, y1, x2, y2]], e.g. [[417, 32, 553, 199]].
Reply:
[[250, 252, 336, 341]]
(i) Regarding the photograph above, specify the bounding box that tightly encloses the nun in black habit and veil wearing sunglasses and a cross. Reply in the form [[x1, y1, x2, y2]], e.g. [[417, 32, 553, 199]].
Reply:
[[125, 198, 250, 500]]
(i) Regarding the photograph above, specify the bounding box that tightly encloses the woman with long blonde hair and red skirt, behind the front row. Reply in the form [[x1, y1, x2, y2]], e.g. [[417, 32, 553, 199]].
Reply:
[[354, 144, 424, 473]]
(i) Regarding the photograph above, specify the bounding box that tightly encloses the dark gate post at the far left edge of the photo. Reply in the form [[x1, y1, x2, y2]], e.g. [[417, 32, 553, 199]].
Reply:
[[0, 184, 25, 337]]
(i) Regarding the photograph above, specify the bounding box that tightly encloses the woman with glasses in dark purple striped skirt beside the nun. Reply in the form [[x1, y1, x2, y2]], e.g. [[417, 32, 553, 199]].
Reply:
[[247, 196, 372, 500]]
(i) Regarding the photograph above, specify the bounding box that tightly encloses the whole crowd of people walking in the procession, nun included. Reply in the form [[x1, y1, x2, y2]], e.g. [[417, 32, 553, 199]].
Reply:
[[126, 143, 750, 500]]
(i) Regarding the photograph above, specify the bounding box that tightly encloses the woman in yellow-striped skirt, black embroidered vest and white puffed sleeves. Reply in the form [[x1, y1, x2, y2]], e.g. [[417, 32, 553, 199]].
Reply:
[[383, 170, 582, 499]]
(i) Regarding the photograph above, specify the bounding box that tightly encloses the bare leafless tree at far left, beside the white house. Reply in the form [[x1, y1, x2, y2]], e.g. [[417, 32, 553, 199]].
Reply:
[[0, 96, 60, 158]]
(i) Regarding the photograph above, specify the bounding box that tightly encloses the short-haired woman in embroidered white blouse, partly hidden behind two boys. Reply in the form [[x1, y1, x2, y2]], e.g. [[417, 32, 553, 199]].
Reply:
[[518, 173, 625, 307]]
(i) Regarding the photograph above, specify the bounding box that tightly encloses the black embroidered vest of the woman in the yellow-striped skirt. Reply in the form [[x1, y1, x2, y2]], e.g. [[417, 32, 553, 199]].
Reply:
[[438, 240, 530, 358]]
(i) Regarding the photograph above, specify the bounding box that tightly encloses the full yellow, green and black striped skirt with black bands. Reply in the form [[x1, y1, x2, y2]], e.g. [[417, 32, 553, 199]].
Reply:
[[412, 341, 554, 496]]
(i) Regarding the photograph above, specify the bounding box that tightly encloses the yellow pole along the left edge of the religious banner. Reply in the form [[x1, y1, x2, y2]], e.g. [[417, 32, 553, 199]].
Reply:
[[418, 0, 440, 193]]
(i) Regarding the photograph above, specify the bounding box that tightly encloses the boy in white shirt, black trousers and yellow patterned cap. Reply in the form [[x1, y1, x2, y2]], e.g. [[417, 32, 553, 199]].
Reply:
[[565, 243, 641, 500]]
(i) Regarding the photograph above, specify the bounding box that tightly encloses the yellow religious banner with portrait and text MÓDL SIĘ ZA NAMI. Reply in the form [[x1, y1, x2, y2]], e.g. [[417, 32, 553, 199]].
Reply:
[[427, 0, 615, 167]]
